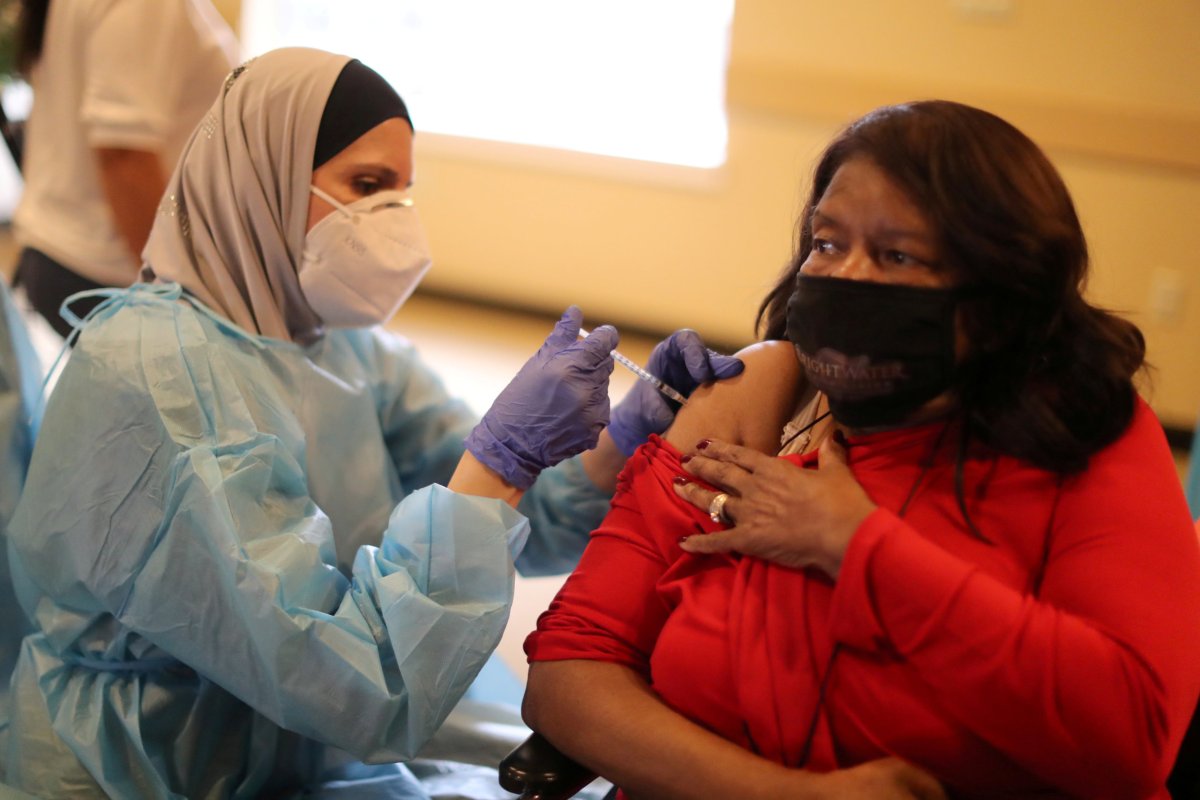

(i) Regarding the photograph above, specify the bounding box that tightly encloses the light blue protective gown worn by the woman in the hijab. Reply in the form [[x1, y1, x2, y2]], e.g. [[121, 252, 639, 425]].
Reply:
[[6, 285, 607, 798]]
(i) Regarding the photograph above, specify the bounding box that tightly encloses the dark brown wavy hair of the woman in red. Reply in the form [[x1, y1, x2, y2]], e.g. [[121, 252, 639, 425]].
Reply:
[[757, 101, 1146, 474]]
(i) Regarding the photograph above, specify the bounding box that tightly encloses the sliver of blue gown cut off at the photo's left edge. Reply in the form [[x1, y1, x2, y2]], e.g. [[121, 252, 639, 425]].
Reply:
[[0, 281, 42, 762]]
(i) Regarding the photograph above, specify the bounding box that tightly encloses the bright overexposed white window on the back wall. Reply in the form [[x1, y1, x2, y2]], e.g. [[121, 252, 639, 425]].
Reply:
[[241, 0, 733, 169]]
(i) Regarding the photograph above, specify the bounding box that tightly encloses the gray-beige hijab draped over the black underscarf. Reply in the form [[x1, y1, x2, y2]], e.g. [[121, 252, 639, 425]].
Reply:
[[142, 48, 349, 344]]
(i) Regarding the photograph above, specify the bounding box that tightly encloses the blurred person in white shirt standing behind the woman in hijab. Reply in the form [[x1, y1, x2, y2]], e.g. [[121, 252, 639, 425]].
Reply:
[[13, 0, 238, 337]]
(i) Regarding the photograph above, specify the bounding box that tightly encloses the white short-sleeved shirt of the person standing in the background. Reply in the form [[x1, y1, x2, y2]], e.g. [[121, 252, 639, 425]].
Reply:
[[13, 0, 238, 285]]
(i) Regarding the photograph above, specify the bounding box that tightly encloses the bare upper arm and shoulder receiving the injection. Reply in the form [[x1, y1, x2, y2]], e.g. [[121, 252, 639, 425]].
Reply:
[[666, 342, 803, 453]]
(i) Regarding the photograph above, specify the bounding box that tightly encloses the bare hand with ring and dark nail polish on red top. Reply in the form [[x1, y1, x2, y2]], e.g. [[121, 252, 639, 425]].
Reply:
[[674, 438, 875, 578]]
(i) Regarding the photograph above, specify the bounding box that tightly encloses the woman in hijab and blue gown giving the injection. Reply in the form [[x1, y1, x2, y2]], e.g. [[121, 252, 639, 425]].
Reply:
[[5, 49, 740, 798]]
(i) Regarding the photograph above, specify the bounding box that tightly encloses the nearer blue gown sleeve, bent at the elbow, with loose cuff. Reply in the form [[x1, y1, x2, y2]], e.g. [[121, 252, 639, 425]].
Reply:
[[13, 304, 528, 762]]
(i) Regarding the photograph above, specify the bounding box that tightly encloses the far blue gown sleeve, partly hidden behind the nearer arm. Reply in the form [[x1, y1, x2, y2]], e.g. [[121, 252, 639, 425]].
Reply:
[[364, 330, 612, 576]]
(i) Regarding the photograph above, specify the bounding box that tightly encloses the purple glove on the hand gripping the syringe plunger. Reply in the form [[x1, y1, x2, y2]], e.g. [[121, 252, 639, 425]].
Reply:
[[466, 306, 619, 489]]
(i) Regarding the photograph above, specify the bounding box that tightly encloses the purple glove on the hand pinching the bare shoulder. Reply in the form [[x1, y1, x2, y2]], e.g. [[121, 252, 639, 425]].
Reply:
[[608, 327, 745, 458]]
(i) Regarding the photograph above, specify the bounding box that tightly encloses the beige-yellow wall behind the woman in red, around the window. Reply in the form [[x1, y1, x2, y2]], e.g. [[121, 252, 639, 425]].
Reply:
[[221, 0, 1200, 426]]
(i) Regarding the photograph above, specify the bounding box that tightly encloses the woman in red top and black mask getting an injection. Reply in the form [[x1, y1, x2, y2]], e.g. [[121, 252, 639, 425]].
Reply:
[[524, 101, 1200, 798]]
